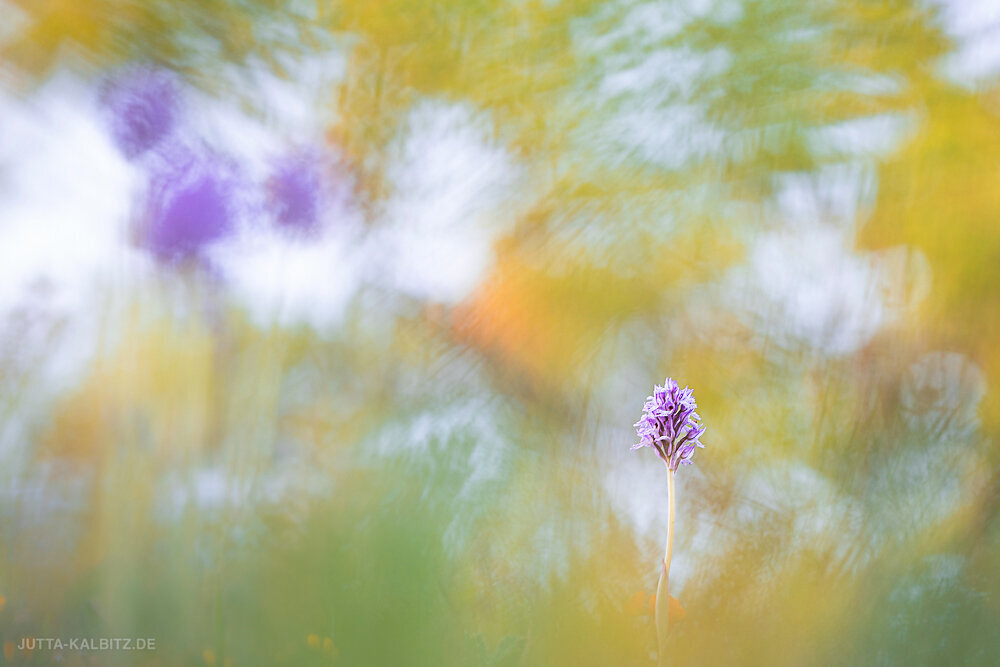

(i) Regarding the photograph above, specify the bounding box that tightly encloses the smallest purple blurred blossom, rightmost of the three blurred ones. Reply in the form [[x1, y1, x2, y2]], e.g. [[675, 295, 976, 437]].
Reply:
[[267, 155, 322, 233]]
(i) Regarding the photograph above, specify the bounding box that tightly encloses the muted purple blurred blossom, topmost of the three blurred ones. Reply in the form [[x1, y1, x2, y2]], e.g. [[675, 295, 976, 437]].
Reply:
[[102, 66, 178, 160]]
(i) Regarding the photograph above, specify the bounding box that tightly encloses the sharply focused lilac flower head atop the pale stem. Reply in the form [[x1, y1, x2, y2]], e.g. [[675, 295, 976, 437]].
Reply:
[[632, 378, 705, 472]]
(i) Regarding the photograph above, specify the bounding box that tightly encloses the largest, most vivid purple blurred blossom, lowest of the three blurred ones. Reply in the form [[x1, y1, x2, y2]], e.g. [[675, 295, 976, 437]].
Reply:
[[143, 152, 235, 263]]
